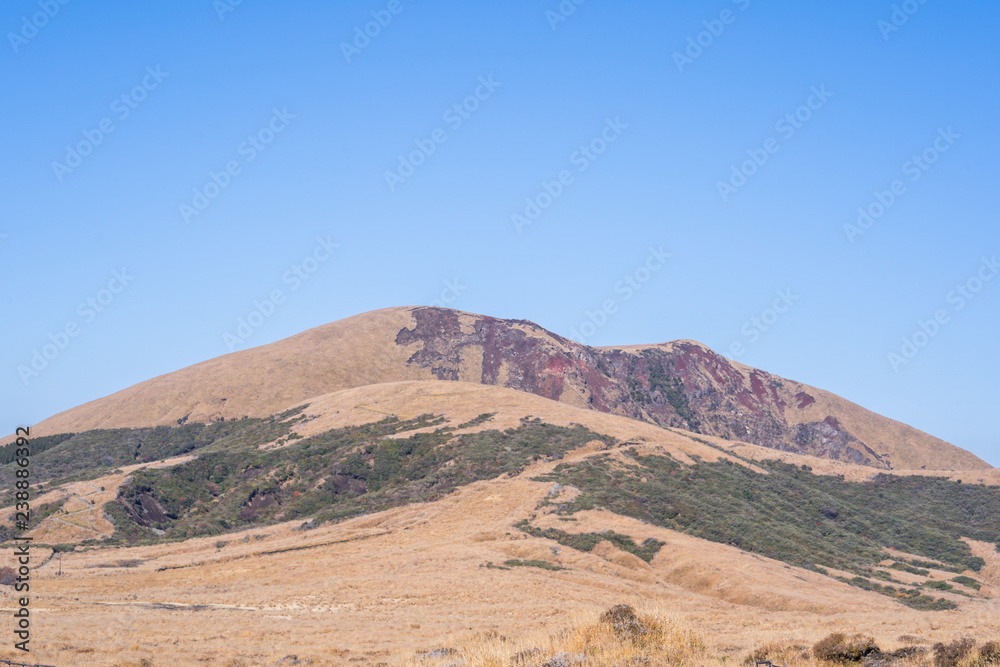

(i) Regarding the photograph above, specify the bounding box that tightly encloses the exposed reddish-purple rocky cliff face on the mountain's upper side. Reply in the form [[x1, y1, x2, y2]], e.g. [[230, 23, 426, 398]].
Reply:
[[396, 308, 892, 468]]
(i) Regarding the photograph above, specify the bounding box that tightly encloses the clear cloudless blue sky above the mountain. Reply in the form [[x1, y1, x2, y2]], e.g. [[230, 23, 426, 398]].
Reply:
[[0, 0, 1000, 465]]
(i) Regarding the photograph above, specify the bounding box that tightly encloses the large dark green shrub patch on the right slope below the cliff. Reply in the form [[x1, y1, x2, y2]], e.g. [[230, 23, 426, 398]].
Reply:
[[539, 450, 1000, 609]]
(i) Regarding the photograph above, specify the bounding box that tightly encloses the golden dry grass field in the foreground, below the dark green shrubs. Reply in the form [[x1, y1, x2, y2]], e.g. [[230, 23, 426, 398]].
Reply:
[[0, 438, 1000, 667]]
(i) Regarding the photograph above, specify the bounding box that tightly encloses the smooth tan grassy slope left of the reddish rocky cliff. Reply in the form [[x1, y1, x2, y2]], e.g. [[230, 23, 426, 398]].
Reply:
[[0, 308, 434, 444]]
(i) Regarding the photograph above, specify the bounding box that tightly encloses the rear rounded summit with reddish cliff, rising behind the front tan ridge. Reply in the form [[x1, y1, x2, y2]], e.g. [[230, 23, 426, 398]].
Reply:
[[9, 307, 990, 470]]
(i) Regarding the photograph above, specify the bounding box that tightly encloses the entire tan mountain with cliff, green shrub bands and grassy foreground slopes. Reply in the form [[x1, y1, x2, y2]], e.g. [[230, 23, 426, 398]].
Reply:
[[0, 308, 1000, 666]]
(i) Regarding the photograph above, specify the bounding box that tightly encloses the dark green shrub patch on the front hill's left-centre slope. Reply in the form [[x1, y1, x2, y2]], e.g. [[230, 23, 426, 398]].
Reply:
[[108, 415, 610, 542]]
